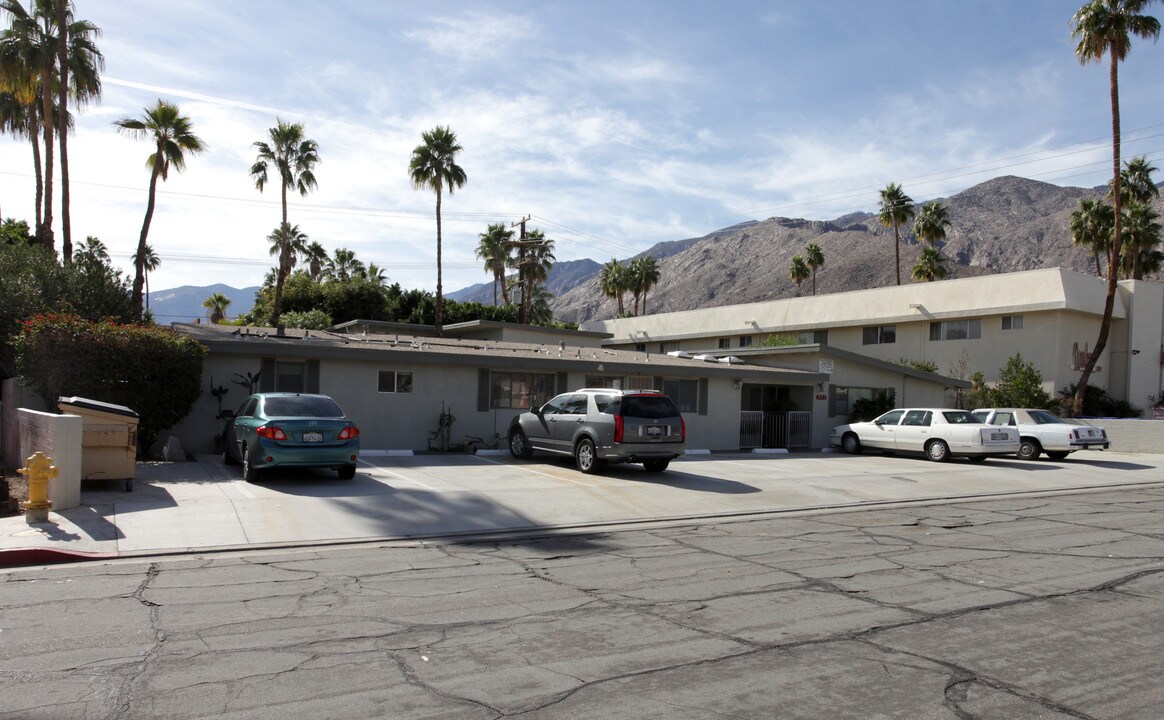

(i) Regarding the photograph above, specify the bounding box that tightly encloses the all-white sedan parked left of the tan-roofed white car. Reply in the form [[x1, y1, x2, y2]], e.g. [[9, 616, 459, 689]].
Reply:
[[829, 407, 1020, 463]]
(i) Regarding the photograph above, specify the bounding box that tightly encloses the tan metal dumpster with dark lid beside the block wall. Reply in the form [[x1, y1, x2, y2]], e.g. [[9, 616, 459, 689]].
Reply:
[[57, 397, 140, 492]]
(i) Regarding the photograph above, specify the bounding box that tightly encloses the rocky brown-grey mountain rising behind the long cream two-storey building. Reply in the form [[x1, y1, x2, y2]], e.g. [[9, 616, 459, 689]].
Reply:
[[552, 177, 1164, 322]]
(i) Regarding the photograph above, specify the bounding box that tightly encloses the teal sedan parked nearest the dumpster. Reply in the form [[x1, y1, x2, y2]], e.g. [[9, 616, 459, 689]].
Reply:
[[222, 392, 360, 483]]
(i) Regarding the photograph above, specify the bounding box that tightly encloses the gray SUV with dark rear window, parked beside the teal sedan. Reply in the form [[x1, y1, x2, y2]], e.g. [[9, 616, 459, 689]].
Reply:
[[509, 388, 687, 473]]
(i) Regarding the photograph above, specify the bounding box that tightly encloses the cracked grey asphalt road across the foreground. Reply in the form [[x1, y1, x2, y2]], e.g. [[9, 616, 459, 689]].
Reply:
[[0, 469, 1164, 720]]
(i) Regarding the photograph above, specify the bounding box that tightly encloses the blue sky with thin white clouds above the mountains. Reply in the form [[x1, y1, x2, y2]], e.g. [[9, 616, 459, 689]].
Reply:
[[0, 0, 1164, 291]]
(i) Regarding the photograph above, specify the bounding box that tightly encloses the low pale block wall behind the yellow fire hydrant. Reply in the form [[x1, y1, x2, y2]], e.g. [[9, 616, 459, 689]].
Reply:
[[17, 408, 84, 511]]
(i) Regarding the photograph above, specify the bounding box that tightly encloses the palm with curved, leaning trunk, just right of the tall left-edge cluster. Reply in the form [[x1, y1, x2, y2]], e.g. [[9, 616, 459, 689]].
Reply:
[[113, 99, 206, 320]]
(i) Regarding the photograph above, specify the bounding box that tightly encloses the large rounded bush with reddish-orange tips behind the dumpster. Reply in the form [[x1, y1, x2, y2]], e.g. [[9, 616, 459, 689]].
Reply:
[[15, 313, 206, 449]]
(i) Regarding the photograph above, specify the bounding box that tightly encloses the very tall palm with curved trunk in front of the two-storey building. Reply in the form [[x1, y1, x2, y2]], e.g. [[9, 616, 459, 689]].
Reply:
[[1071, 0, 1161, 414]]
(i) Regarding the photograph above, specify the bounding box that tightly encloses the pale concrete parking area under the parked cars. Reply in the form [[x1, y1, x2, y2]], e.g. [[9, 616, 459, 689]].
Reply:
[[0, 451, 1164, 564]]
